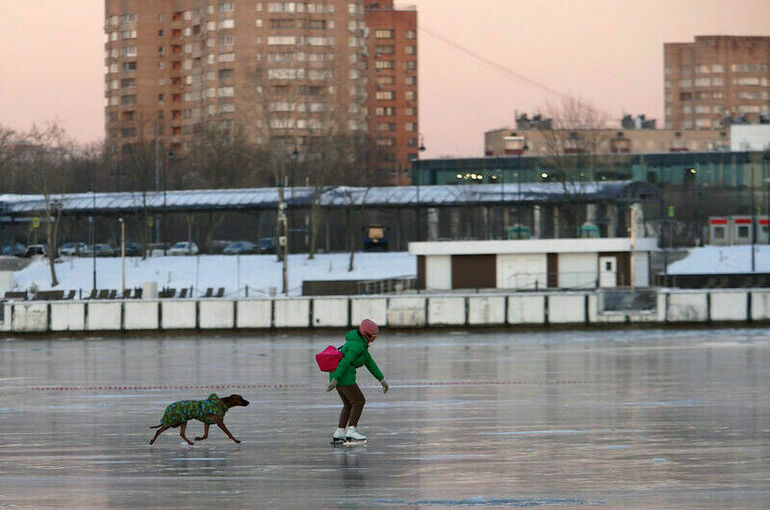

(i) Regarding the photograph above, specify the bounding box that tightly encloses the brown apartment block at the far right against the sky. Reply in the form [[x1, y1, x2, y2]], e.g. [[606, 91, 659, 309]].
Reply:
[[664, 35, 770, 130]]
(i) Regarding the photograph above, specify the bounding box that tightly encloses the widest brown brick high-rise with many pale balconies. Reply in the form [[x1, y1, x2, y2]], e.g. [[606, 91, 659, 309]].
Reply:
[[104, 0, 367, 165]]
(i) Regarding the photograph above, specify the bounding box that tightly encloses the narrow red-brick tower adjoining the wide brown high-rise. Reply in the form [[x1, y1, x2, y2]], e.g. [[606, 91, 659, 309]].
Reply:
[[364, 0, 422, 185]]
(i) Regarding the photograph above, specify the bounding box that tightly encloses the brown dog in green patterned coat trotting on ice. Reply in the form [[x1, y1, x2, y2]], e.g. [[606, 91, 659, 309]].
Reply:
[[150, 393, 249, 444]]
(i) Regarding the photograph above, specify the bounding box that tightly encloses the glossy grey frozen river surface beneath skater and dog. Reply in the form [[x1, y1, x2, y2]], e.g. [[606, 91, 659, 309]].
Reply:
[[0, 329, 770, 510]]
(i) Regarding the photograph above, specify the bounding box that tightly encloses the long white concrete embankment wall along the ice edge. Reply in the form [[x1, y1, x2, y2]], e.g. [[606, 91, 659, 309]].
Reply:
[[7, 289, 770, 333]]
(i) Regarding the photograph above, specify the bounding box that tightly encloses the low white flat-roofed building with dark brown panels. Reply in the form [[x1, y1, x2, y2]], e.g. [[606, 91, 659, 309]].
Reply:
[[409, 237, 658, 290]]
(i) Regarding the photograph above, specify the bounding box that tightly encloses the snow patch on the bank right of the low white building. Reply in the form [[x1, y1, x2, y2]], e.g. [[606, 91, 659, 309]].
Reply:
[[668, 245, 770, 274]]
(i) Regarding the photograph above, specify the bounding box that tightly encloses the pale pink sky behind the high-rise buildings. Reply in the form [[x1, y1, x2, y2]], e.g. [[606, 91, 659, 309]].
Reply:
[[0, 0, 770, 157]]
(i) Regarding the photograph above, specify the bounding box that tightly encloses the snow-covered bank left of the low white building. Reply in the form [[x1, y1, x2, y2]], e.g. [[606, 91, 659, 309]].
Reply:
[[13, 252, 417, 296]]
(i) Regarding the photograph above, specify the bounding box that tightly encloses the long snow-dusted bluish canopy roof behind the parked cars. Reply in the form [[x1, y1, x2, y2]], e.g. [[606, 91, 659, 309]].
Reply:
[[0, 181, 657, 216]]
